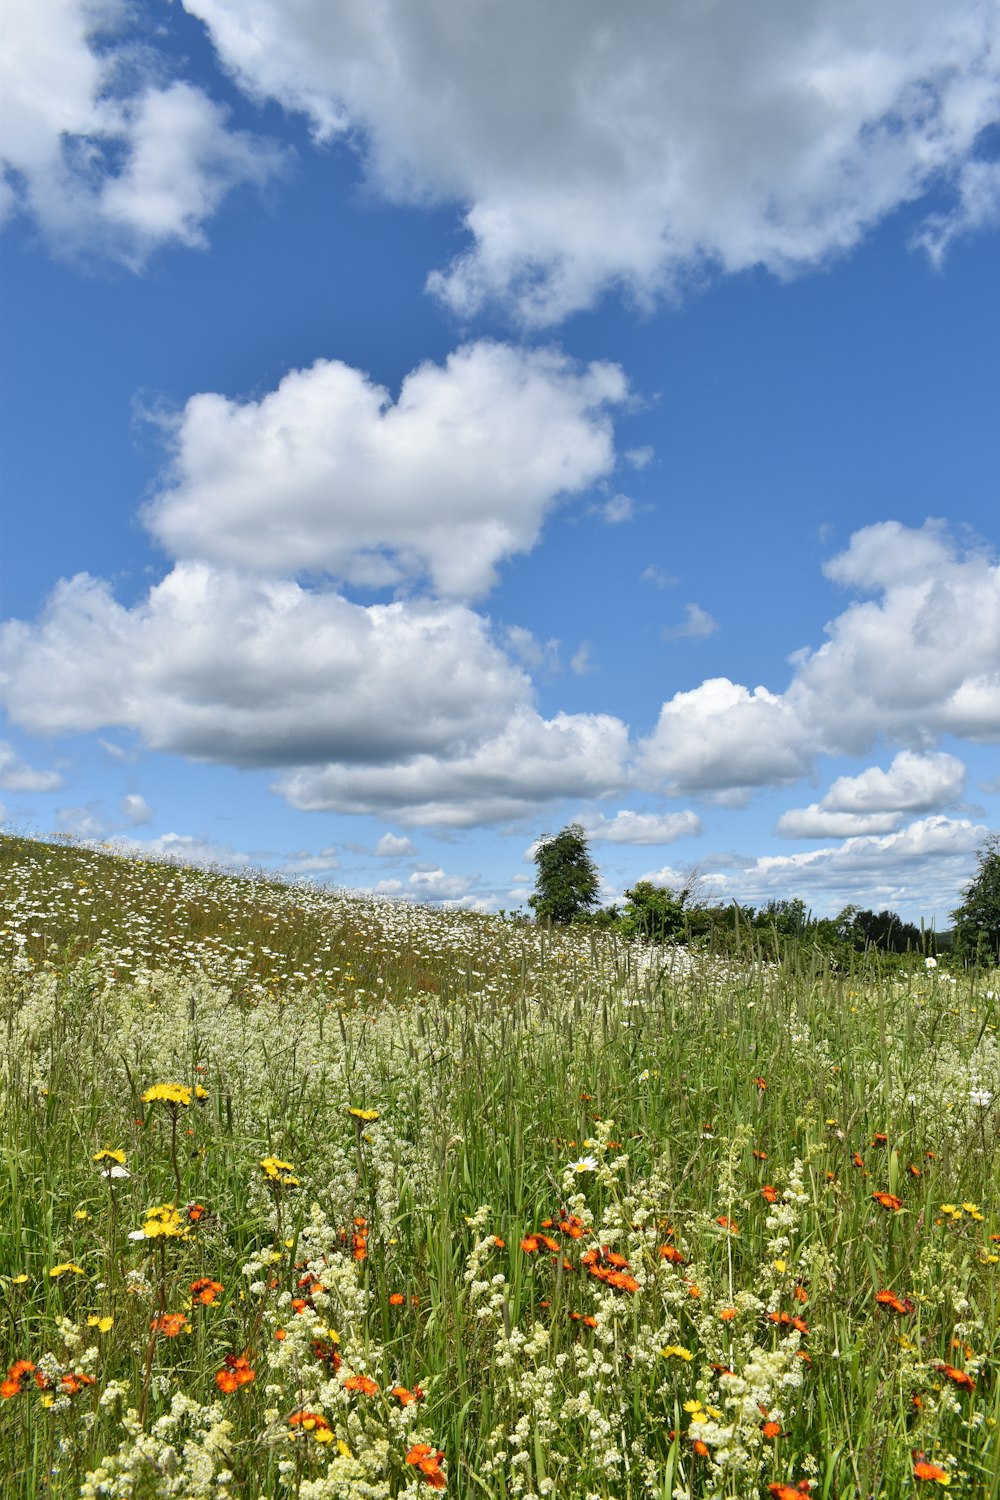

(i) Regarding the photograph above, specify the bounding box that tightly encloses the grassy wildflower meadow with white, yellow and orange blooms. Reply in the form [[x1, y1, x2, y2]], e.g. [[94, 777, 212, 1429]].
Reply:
[[0, 839, 1000, 1500]]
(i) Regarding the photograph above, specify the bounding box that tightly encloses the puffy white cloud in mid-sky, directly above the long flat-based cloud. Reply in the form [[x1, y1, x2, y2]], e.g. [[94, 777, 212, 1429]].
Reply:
[[145, 341, 627, 596]]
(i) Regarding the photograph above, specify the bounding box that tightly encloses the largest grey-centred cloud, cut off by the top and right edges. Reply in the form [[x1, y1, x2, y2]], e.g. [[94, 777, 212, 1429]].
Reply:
[[184, 0, 1000, 323]]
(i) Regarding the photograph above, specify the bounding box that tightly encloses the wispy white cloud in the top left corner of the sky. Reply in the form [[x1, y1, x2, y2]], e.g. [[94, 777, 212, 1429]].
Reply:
[[0, 0, 282, 269]]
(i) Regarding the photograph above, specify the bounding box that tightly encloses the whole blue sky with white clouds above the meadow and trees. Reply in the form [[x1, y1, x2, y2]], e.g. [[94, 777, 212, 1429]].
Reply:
[[0, 0, 1000, 926]]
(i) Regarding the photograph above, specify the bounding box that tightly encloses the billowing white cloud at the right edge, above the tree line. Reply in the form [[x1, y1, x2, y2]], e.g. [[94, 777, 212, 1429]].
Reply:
[[640, 521, 1000, 804]]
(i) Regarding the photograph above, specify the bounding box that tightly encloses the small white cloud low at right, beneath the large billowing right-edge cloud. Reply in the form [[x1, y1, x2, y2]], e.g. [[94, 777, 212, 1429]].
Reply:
[[775, 750, 966, 839]]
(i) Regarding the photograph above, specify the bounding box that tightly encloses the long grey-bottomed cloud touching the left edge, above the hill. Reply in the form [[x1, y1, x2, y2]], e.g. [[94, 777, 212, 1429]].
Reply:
[[0, 563, 531, 765]]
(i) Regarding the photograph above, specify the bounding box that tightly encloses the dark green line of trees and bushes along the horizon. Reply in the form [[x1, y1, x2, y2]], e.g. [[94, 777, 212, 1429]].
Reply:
[[529, 824, 1000, 965]]
